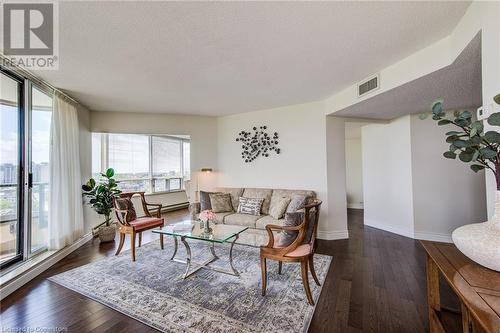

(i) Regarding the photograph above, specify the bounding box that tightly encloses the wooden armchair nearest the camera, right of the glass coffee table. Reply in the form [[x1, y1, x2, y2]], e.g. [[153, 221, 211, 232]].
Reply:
[[260, 200, 322, 305]]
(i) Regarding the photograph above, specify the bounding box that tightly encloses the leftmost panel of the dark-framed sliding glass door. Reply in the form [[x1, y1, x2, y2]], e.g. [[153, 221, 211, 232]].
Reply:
[[0, 71, 24, 267]]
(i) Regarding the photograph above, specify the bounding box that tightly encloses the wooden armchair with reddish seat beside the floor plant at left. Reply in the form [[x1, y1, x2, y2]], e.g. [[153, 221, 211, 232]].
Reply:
[[113, 192, 164, 261]]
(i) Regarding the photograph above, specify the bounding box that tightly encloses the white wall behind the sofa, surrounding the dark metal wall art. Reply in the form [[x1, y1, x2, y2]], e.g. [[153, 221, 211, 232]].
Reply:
[[217, 103, 345, 238]]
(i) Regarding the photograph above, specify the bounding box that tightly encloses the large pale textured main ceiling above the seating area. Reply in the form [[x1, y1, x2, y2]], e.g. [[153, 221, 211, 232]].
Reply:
[[36, 1, 470, 115]]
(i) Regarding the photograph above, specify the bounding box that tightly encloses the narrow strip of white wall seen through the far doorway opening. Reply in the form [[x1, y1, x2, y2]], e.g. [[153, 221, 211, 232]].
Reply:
[[345, 137, 363, 209]]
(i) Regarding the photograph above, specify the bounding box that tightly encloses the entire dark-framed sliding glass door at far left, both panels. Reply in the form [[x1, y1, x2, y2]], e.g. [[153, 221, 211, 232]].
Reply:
[[0, 68, 52, 268]]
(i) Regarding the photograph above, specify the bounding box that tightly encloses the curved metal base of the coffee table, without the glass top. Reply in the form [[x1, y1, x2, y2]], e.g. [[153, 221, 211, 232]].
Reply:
[[170, 235, 240, 279]]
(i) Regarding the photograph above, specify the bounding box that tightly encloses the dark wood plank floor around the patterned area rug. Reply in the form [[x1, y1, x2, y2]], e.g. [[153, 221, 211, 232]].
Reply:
[[0, 210, 457, 333]]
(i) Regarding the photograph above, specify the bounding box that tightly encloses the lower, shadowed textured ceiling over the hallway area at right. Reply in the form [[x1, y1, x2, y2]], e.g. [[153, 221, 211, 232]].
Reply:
[[332, 34, 482, 119]]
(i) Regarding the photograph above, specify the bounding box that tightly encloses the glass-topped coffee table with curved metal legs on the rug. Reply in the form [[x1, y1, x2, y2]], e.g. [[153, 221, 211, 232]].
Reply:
[[153, 221, 248, 279]]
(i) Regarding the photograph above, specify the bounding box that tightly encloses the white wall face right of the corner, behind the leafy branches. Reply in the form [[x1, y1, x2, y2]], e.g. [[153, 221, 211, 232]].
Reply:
[[411, 115, 487, 241]]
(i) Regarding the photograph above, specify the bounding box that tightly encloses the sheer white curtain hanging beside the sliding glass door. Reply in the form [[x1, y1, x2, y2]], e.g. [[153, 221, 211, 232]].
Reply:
[[49, 93, 83, 250]]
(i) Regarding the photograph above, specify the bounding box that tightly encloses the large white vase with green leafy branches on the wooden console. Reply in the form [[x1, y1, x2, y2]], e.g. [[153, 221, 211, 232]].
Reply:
[[420, 94, 500, 271]]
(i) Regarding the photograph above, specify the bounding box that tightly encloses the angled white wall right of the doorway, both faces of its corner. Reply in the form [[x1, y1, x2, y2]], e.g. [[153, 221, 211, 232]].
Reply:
[[362, 115, 486, 242]]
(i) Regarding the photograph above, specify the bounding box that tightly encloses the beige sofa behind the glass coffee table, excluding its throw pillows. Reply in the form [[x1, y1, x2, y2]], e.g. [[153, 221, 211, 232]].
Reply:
[[190, 187, 316, 229]]
